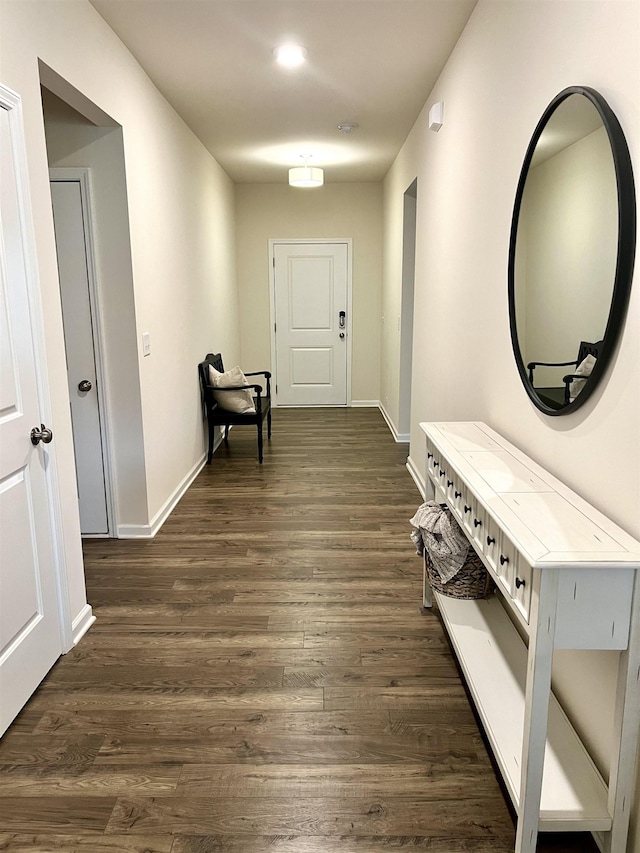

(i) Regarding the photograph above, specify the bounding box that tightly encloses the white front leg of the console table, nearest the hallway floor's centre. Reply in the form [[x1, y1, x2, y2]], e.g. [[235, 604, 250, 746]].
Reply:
[[515, 569, 558, 853]]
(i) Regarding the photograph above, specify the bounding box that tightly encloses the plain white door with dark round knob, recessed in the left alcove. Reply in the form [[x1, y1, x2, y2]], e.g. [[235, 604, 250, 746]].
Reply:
[[51, 175, 109, 535]]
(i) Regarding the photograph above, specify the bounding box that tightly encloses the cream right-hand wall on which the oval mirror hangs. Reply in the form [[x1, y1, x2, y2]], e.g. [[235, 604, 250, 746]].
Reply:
[[382, 0, 640, 850]]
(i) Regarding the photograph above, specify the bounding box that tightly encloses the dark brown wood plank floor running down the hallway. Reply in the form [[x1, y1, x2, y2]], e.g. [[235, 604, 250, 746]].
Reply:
[[0, 409, 596, 853]]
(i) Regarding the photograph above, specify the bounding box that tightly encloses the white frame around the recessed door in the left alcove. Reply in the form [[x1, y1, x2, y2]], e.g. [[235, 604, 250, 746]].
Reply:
[[49, 167, 116, 539]]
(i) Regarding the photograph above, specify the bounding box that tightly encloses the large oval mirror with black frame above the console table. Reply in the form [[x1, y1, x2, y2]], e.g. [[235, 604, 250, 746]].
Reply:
[[509, 86, 636, 415]]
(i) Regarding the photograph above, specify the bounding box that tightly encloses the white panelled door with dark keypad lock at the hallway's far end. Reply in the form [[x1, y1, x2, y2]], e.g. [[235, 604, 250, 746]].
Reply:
[[273, 242, 349, 406]]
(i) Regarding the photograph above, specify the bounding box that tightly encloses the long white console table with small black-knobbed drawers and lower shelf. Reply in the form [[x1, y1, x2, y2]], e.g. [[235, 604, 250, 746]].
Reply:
[[420, 422, 640, 853]]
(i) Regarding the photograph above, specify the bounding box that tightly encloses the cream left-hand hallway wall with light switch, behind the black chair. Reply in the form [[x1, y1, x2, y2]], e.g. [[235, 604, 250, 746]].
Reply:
[[0, 0, 240, 618]]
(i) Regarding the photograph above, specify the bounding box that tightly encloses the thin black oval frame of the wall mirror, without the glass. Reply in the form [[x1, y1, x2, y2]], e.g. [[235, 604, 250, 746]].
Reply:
[[508, 86, 636, 416]]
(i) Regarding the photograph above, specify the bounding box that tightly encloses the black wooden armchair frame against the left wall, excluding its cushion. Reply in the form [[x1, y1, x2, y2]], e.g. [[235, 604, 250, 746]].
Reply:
[[198, 353, 271, 465]]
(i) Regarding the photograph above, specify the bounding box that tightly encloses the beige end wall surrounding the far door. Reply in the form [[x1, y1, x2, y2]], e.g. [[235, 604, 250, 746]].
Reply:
[[236, 183, 382, 404]]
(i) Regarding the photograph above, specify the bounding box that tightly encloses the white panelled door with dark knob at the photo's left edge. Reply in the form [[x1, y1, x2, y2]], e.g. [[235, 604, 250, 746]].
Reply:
[[0, 87, 62, 734]]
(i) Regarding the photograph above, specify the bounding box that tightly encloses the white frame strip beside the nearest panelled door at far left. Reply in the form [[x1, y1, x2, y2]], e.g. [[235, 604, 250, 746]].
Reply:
[[0, 84, 74, 654]]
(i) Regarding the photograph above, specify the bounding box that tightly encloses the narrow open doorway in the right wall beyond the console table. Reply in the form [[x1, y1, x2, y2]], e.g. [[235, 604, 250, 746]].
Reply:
[[398, 178, 418, 441]]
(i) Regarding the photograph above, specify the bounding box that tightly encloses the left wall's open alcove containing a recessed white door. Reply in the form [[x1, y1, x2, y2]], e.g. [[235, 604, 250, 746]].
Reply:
[[40, 75, 144, 537]]
